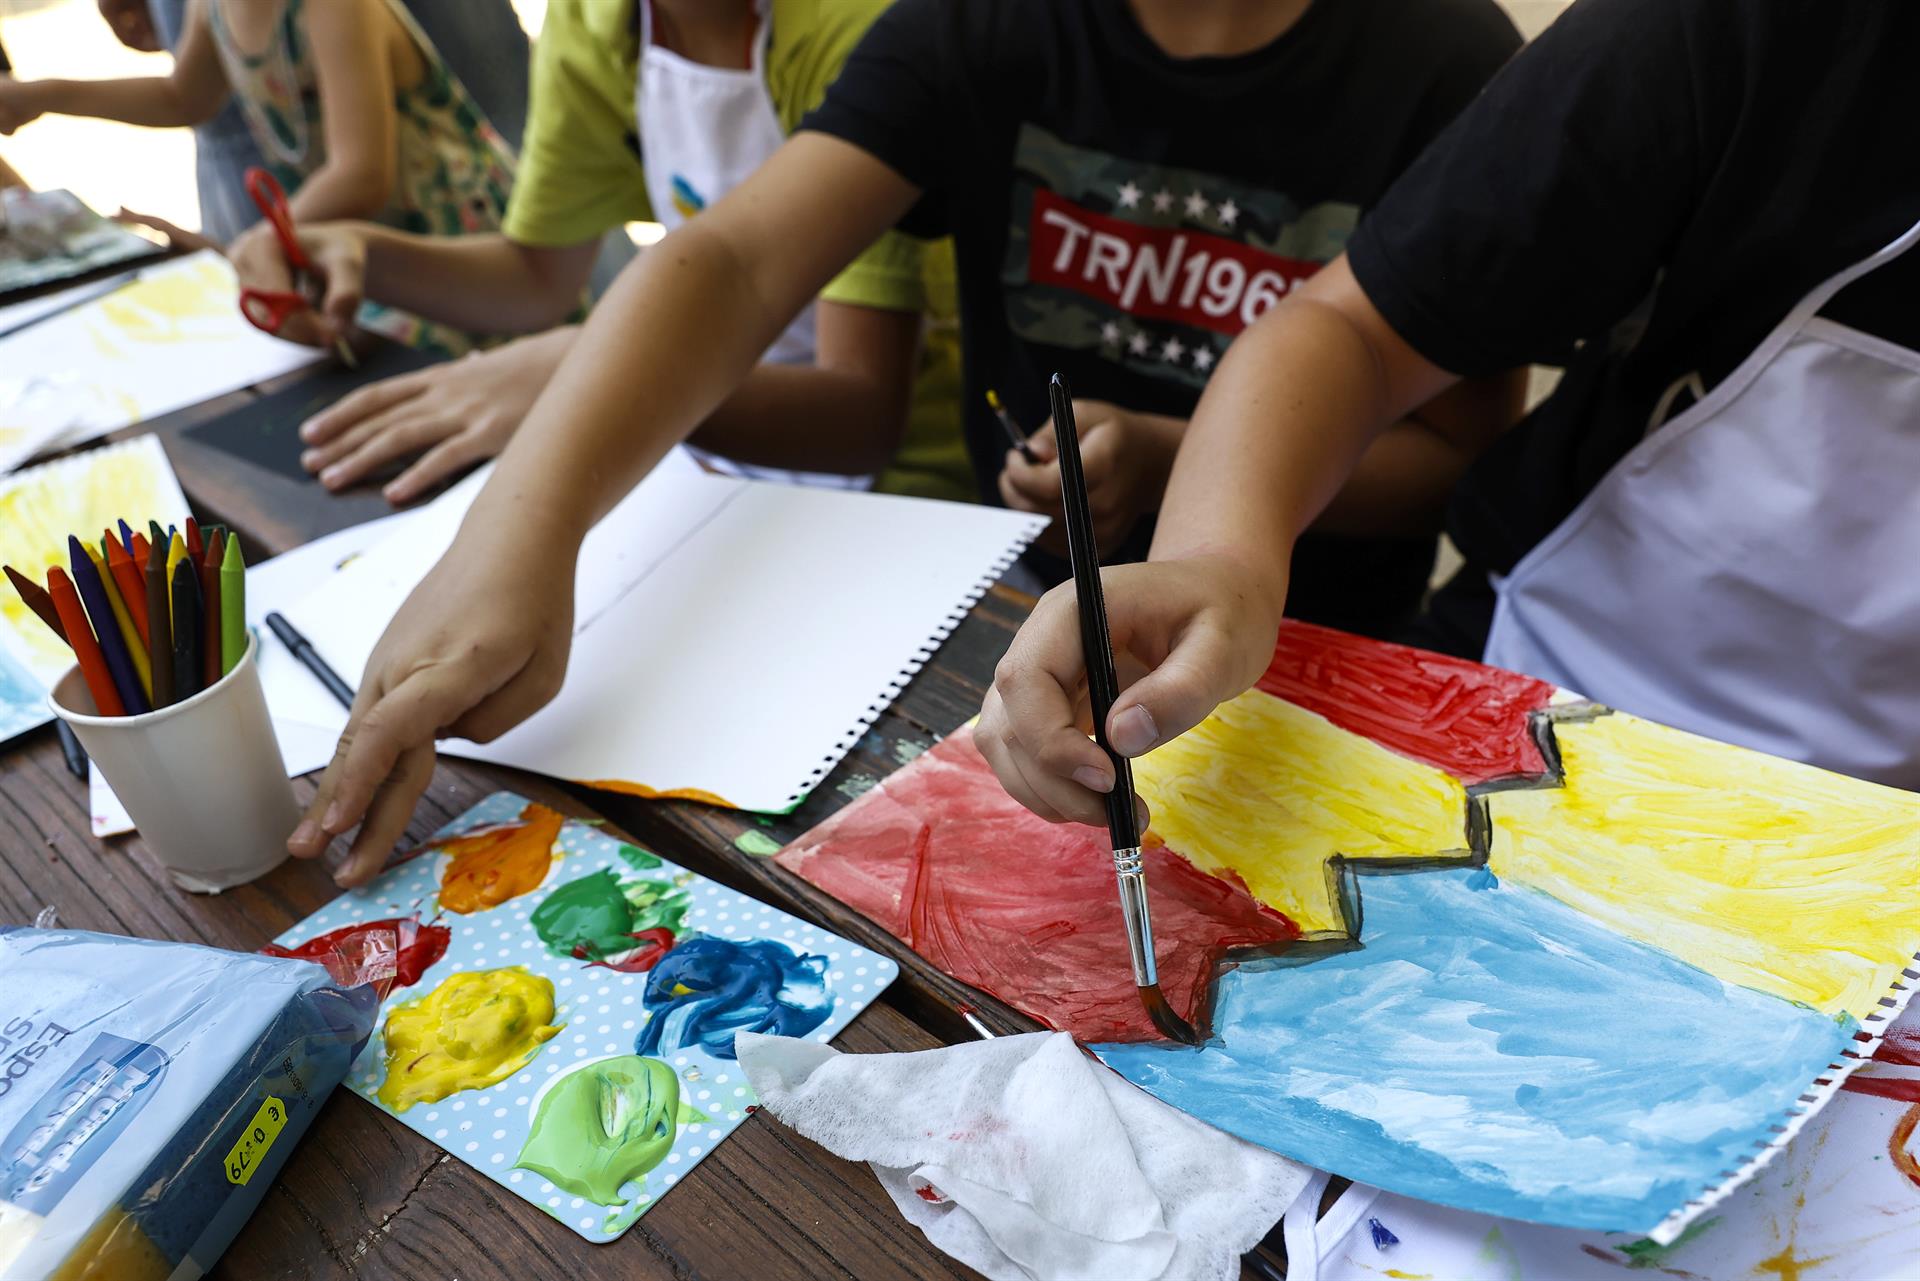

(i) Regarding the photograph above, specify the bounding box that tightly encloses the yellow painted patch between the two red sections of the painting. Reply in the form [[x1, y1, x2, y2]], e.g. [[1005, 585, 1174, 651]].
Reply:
[[1133, 689, 1467, 937]]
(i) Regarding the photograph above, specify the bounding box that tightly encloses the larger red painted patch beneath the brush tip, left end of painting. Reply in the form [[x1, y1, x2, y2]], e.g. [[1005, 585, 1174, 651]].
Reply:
[[776, 730, 1300, 1041]]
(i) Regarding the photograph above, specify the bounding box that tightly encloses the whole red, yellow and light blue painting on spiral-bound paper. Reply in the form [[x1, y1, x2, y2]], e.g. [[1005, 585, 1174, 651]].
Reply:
[[780, 624, 1920, 1241]]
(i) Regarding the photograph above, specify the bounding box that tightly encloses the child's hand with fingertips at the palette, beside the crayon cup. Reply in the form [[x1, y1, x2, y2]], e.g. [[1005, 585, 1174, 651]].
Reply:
[[286, 505, 578, 885]]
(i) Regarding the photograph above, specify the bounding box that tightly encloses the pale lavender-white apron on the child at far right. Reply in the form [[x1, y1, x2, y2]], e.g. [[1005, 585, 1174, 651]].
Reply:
[[1486, 223, 1920, 787]]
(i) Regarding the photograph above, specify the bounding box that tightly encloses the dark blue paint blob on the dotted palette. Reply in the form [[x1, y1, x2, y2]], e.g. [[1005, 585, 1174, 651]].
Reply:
[[634, 935, 833, 1058]]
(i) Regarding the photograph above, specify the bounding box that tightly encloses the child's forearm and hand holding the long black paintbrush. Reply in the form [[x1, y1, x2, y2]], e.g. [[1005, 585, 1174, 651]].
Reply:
[[973, 257, 1455, 824]]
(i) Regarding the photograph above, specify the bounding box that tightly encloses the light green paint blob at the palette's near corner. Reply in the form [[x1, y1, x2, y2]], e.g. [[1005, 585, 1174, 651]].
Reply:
[[515, 1054, 680, 1218]]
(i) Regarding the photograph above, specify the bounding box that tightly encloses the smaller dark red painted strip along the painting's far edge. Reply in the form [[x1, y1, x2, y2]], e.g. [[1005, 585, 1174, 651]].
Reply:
[[1260, 620, 1553, 786]]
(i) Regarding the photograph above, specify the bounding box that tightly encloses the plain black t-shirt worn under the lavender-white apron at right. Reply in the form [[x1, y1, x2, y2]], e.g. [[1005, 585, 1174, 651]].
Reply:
[[1350, 0, 1920, 651]]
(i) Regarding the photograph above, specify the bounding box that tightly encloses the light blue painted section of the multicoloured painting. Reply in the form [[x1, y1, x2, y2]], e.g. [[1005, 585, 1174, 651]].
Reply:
[[1094, 868, 1855, 1231]]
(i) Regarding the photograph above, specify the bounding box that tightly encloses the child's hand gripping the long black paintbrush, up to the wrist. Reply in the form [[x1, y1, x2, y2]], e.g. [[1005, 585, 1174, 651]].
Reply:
[[973, 555, 1286, 826]]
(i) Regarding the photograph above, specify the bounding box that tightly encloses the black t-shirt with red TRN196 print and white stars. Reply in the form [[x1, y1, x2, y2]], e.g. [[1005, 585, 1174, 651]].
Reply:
[[803, 0, 1519, 637]]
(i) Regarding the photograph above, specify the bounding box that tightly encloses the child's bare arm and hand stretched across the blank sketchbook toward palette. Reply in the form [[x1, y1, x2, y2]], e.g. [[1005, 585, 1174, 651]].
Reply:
[[288, 131, 918, 883]]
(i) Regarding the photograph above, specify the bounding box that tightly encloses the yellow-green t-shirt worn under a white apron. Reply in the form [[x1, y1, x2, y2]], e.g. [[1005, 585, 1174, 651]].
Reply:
[[503, 0, 975, 499]]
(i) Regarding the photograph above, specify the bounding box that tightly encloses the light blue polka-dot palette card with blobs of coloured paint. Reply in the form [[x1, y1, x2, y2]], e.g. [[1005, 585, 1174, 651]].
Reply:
[[276, 791, 899, 1241]]
